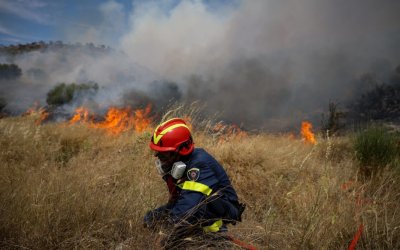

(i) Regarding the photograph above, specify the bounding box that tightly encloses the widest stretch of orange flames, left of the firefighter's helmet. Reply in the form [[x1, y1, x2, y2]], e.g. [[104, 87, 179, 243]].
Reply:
[[69, 105, 152, 135]]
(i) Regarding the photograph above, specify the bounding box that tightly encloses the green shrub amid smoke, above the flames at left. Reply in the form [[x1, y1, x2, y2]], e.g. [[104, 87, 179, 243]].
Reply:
[[46, 83, 99, 106]]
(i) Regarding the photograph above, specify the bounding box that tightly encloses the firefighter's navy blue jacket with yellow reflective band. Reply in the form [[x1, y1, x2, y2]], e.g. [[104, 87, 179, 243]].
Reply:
[[164, 148, 238, 224]]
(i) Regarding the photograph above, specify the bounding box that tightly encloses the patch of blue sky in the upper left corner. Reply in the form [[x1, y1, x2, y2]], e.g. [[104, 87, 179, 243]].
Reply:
[[0, 0, 132, 45]]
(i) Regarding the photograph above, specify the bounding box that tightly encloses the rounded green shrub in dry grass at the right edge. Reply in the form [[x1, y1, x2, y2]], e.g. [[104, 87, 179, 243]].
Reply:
[[354, 126, 400, 173]]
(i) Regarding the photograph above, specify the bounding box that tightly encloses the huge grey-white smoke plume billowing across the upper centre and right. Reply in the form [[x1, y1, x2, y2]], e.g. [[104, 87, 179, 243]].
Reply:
[[121, 0, 400, 129]]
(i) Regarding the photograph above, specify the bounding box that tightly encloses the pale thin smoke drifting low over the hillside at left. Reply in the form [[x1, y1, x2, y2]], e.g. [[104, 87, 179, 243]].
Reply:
[[0, 45, 157, 114]]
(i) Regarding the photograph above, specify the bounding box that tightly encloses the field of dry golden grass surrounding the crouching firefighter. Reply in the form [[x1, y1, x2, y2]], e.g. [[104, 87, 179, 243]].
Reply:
[[0, 112, 400, 249]]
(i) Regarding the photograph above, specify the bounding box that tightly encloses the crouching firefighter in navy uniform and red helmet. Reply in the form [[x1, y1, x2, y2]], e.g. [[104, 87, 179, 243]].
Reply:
[[144, 118, 245, 242]]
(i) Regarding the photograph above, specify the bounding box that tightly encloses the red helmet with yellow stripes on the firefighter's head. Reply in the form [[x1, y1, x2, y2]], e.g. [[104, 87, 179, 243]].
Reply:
[[150, 118, 194, 155]]
